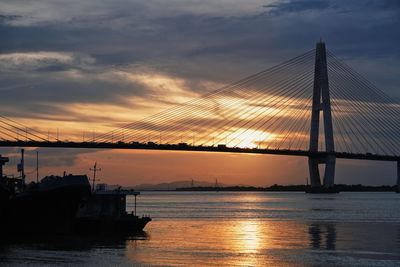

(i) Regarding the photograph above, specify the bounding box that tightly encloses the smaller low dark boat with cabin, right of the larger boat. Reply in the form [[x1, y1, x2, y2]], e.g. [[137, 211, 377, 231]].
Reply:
[[75, 184, 151, 234]]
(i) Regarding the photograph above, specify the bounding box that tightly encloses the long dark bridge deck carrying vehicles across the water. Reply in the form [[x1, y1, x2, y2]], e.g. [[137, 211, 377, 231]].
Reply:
[[0, 141, 400, 161]]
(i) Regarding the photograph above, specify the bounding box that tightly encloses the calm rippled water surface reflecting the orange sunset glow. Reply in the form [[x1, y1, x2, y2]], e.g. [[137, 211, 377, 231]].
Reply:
[[0, 192, 400, 266]]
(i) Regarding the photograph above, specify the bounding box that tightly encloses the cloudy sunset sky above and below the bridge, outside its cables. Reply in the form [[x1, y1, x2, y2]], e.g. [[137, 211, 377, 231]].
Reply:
[[0, 0, 400, 186]]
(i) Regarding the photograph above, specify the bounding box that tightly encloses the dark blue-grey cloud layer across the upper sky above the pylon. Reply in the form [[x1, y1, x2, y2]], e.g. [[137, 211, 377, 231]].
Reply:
[[0, 0, 400, 115]]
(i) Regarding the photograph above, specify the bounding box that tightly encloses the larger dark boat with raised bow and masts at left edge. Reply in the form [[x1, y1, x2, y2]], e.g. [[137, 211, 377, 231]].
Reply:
[[0, 149, 91, 234]]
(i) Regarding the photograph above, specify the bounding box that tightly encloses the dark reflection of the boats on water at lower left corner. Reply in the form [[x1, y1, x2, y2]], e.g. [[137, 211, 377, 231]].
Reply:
[[0, 232, 148, 266]]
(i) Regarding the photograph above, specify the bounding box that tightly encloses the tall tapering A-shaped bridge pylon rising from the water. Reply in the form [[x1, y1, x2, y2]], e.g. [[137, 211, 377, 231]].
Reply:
[[308, 41, 336, 188]]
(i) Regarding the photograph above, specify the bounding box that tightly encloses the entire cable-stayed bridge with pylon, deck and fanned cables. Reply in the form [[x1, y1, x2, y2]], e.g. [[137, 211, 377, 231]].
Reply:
[[0, 42, 400, 192]]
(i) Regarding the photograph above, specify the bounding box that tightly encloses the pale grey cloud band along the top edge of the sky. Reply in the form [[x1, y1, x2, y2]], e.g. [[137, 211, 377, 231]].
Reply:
[[0, 0, 269, 29]]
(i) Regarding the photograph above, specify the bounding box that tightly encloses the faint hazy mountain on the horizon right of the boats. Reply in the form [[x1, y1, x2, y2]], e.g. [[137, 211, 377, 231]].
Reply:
[[128, 180, 241, 191]]
